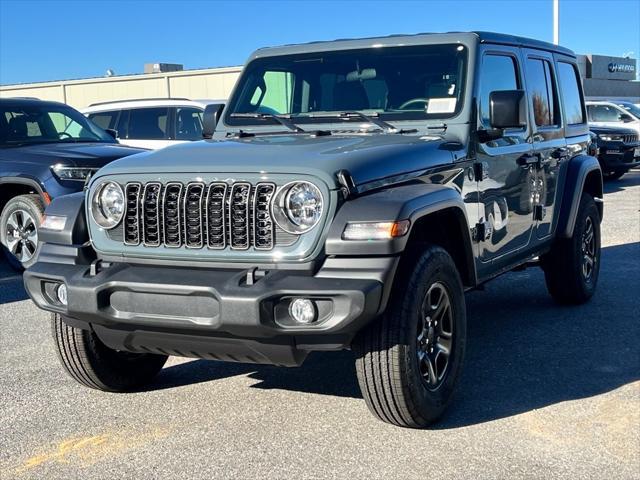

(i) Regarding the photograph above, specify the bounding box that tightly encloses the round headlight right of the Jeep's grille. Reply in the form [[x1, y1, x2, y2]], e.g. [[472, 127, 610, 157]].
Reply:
[[273, 182, 323, 234]]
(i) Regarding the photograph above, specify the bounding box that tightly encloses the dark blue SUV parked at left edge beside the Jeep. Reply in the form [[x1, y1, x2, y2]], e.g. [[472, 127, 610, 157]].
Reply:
[[0, 98, 143, 268]]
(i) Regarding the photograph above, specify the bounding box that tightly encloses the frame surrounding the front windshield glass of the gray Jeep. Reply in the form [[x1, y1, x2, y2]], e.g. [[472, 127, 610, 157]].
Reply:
[[222, 41, 474, 130]]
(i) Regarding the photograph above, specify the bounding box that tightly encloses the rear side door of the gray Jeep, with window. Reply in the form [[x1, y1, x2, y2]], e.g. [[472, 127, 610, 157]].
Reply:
[[523, 49, 569, 240]]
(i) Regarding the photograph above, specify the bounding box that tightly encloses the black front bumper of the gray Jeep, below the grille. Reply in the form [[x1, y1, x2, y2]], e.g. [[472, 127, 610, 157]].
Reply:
[[24, 249, 398, 365]]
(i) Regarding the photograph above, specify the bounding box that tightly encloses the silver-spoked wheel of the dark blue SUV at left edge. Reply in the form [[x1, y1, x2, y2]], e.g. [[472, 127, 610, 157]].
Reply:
[[0, 195, 44, 270]]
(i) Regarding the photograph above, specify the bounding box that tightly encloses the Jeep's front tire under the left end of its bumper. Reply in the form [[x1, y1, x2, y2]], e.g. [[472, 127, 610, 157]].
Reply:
[[51, 313, 167, 392]]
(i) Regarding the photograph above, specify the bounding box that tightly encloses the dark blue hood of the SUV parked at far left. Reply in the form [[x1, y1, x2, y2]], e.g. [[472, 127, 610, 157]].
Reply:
[[0, 142, 146, 168]]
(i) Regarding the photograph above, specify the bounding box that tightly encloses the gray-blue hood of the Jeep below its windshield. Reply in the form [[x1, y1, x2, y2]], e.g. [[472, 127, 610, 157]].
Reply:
[[94, 133, 453, 188]]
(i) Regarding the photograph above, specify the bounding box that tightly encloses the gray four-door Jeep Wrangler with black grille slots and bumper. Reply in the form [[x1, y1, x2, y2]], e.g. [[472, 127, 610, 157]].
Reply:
[[24, 33, 603, 427]]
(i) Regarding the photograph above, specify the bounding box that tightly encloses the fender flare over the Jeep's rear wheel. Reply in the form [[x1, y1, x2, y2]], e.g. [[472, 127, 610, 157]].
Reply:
[[557, 155, 604, 238]]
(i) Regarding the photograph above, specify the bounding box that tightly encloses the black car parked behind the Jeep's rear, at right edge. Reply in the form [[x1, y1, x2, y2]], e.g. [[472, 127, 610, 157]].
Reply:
[[590, 126, 640, 179]]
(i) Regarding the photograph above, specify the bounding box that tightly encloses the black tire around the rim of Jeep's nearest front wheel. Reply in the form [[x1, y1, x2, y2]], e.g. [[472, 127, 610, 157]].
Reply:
[[353, 245, 466, 428]]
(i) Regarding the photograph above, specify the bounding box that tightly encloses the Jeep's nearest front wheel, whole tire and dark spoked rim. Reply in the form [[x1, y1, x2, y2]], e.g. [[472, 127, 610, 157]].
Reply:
[[353, 246, 467, 428]]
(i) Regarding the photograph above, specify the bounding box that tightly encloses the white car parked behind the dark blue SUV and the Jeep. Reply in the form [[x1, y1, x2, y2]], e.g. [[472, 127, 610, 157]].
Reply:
[[82, 98, 226, 150]]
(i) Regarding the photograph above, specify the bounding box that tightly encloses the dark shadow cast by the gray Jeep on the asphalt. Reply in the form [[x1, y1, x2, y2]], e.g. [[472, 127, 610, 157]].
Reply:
[[151, 243, 640, 429]]
